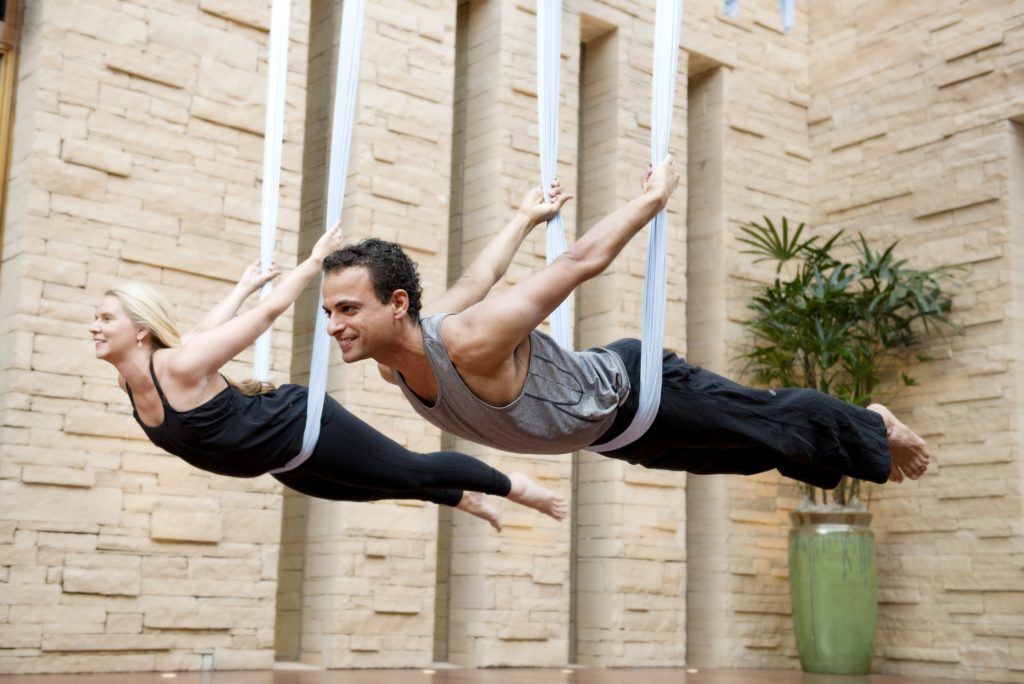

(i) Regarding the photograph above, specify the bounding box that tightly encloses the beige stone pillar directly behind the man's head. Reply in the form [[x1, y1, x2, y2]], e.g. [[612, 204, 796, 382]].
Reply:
[[288, 1, 456, 668]]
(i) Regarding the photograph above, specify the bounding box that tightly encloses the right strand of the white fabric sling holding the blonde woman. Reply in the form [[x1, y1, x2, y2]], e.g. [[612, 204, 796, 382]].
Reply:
[[270, 0, 365, 473]]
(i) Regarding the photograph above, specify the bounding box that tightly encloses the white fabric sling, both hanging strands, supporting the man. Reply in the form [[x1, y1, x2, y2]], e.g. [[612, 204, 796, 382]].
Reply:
[[537, 0, 683, 452]]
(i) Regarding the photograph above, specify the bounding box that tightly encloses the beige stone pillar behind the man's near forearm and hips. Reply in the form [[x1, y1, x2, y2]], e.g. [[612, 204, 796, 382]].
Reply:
[[575, 3, 686, 667]]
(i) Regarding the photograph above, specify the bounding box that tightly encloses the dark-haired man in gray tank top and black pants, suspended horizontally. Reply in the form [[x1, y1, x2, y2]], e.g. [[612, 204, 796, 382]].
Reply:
[[324, 156, 929, 487]]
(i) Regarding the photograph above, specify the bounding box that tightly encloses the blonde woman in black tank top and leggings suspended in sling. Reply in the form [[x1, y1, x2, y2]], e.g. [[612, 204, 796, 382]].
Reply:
[[89, 226, 566, 531]]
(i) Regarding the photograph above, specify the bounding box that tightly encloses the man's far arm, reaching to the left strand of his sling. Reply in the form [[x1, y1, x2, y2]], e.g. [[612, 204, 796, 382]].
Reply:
[[423, 180, 571, 314]]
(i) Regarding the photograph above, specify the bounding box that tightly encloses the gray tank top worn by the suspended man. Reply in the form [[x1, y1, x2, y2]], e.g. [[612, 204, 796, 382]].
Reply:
[[394, 313, 630, 454]]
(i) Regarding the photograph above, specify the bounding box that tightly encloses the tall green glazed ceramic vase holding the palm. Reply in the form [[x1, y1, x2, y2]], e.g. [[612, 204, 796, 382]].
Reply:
[[790, 511, 878, 675]]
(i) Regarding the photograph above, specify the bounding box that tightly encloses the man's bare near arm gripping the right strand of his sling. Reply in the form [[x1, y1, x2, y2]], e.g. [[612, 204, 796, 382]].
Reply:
[[442, 155, 679, 374]]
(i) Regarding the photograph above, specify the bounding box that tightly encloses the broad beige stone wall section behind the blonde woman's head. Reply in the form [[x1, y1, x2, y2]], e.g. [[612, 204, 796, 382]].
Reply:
[[0, 0, 306, 673]]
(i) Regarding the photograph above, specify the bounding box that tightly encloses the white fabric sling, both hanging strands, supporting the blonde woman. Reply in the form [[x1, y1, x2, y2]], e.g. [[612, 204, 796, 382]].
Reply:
[[253, 0, 365, 473]]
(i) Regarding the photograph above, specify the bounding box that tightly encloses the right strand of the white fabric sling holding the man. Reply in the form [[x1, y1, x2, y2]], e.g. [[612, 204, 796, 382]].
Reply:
[[588, 0, 683, 452]]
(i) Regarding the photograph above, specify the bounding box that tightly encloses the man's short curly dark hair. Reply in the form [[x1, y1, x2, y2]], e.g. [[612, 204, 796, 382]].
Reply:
[[324, 238, 423, 323]]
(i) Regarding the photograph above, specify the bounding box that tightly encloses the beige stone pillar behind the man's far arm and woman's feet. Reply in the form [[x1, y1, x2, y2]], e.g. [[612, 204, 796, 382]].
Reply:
[[447, 0, 575, 667]]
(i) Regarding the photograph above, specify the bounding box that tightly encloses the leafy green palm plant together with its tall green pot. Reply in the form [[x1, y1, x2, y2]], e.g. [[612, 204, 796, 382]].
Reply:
[[738, 217, 953, 674]]
